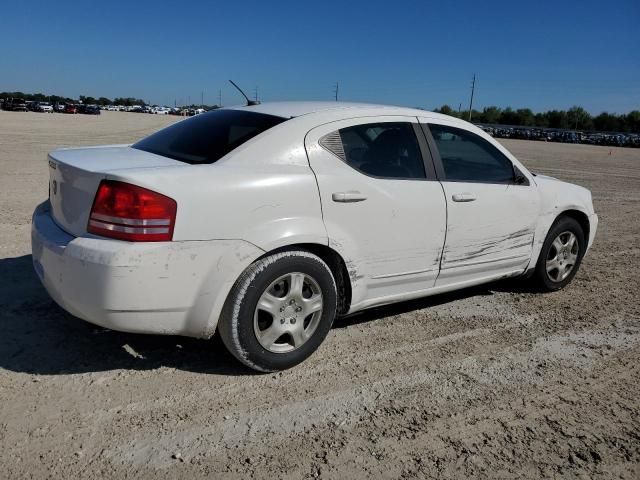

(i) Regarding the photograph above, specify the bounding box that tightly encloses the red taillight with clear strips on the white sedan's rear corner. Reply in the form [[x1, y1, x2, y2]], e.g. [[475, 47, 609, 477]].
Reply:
[[87, 180, 177, 242]]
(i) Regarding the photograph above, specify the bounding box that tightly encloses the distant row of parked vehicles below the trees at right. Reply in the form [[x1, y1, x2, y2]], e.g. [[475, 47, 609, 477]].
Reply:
[[477, 124, 640, 148]]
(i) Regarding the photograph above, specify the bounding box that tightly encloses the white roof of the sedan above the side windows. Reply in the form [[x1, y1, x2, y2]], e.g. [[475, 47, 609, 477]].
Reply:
[[225, 101, 460, 122]]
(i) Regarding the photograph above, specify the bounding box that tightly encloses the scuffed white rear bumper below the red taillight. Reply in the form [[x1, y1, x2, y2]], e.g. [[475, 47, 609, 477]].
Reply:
[[31, 202, 263, 337]]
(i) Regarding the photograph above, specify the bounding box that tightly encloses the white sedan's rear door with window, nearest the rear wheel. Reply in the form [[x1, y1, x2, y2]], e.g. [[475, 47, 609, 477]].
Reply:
[[305, 116, 446, 309]]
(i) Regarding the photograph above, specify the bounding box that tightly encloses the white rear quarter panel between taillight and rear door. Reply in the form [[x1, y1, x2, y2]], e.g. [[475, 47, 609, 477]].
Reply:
[[108, 126, 328, 251]]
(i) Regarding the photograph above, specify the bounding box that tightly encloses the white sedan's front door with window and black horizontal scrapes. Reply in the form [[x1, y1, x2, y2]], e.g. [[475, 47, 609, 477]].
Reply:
[[421, 119, 539, 286]]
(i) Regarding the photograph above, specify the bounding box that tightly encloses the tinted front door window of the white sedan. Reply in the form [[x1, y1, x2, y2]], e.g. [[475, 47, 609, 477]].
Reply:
[[429, 124, 514, 183]]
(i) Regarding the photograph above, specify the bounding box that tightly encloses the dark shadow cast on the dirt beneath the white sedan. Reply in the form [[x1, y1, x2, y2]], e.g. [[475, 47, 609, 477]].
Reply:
[[0, 255, 536, 375]]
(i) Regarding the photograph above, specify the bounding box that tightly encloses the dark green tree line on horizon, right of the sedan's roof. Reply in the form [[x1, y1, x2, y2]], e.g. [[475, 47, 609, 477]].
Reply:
[[434, 105, 640, 133]]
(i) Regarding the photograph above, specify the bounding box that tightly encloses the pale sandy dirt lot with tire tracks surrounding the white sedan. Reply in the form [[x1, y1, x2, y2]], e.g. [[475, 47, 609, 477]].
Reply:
[[0, 112, 640, 479]]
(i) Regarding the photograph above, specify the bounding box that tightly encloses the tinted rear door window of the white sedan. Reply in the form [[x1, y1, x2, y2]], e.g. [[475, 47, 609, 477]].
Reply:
[[324, 122, 426, 179]]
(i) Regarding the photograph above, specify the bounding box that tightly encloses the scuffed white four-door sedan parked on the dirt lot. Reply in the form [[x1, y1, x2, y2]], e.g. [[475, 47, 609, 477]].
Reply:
[[32, 102, 598, 371]]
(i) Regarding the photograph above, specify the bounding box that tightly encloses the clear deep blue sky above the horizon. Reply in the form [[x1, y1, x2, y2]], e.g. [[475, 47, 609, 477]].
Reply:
[[0, 0, 640, 113]]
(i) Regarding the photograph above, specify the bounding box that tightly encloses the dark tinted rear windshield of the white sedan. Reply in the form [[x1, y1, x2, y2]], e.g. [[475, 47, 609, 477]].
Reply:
[[133, 110, 286, 164]]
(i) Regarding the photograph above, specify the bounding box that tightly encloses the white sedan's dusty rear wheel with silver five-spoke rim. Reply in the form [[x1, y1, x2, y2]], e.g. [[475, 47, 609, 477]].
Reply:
[[218, 250, 337, 372]]
